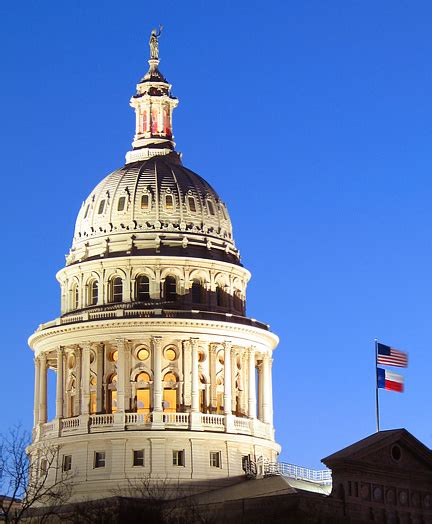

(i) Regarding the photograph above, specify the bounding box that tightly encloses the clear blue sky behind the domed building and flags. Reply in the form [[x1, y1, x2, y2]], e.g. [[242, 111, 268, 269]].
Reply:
[[0, 0, 432, 467]]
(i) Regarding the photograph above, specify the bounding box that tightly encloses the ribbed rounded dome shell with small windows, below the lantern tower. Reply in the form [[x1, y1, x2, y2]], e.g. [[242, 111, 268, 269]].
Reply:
[[67, 152, 239, 264]]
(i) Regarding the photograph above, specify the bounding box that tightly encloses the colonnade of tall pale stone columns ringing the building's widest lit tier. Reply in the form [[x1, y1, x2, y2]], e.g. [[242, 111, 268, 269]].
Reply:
[[34, 336, 273, 426]]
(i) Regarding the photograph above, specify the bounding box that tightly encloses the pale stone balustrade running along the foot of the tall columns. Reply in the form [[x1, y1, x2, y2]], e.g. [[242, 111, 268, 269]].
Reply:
[[33, 412, 274, 440]]
